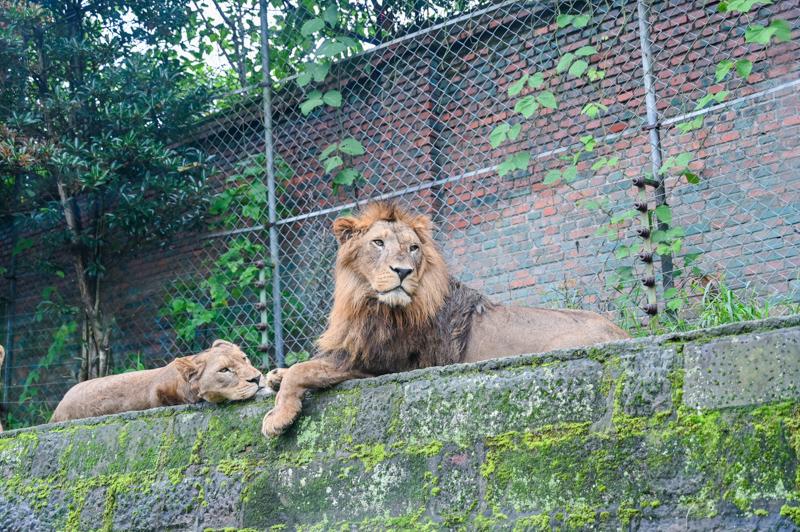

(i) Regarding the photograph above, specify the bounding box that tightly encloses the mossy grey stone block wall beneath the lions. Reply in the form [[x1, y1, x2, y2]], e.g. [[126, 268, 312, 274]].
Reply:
[[0, 317, 800, 531]]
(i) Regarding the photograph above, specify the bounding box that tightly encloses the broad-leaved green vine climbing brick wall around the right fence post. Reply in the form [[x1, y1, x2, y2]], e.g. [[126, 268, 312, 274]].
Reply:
[[489, 0, 791, 329]]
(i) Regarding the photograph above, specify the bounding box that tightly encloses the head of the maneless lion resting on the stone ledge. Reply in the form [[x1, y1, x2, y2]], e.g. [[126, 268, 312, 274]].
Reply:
[[175, 340, 265, 403]]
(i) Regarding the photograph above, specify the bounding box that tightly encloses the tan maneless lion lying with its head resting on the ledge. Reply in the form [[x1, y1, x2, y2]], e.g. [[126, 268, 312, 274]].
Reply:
[[50, 340, 264, 423]]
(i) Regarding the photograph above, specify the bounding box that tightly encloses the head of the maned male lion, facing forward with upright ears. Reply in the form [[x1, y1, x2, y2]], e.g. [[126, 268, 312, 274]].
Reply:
[[333, 203, 447, 308]]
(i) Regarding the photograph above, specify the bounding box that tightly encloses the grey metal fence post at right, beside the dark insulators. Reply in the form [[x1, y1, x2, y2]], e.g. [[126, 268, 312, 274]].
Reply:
[[636, 0, 674, 298]]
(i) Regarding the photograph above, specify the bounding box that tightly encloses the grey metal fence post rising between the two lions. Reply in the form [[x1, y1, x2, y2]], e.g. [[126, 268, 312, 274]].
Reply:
[[259, 0, 285, 367]]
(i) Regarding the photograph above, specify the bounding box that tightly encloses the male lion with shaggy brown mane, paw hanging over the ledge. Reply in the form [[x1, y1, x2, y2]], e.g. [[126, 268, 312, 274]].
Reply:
[[261, 203, 628, 436]]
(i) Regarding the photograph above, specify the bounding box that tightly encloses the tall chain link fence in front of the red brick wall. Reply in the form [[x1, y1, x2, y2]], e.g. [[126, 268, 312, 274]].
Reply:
[[0, 0, 800, 428]]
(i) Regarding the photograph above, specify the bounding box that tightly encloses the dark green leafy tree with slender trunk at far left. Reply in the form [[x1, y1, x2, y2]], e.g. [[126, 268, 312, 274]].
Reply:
[[0, 0, 216, 379]]
